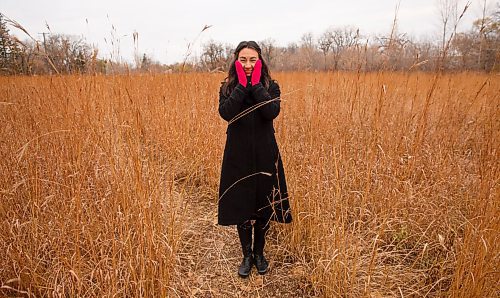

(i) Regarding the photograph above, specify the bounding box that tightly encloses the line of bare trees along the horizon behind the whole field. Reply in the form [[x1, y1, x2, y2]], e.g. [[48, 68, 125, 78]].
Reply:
[[0, 0, 500, 75]]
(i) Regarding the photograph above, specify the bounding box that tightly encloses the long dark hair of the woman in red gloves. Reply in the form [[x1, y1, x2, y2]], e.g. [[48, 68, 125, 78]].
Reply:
[[222, 41, 271, 96]]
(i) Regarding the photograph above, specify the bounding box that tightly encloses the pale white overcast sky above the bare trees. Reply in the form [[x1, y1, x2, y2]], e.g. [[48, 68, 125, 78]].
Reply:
[[0, 0, 498, 63]]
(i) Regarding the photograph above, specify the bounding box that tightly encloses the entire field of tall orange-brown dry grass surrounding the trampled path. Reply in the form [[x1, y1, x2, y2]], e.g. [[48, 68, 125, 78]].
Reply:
[[0, 72, 500, 297]]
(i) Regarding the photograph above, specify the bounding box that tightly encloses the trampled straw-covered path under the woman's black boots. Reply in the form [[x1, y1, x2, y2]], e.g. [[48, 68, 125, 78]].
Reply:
[[170, 191, 311, 297]]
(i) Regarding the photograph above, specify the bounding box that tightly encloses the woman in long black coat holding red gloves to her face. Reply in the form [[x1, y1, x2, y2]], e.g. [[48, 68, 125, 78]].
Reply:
[[218, 41, 292, 277]]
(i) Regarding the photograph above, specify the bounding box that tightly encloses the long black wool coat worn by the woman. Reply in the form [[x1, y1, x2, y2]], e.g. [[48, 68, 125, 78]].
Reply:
[[218, 81, 292, 225]]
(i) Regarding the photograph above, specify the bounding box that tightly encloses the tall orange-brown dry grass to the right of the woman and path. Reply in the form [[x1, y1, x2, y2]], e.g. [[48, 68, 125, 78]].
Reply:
[[277, 73, 500, 297]]
